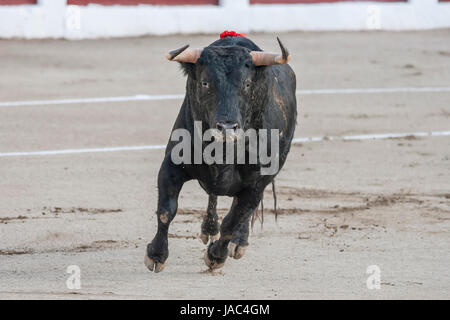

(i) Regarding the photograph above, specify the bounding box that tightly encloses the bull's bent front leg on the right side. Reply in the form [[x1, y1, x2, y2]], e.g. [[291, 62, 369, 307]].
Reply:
[[204, 189, 264, 269]]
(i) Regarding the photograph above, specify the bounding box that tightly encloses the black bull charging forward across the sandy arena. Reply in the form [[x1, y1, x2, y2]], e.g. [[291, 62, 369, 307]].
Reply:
[[145, 37, 297, 272]]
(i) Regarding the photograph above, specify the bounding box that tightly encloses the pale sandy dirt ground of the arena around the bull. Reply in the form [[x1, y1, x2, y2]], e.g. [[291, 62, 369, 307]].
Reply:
[[0, 30, 450, 299]]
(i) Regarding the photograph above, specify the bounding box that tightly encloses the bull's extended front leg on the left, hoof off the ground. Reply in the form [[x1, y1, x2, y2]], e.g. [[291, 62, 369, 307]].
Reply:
[[145, 154, 188, 273]]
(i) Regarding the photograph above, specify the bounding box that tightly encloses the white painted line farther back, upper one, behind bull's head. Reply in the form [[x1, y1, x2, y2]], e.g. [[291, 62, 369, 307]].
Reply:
[[0, 87, 450, 107]]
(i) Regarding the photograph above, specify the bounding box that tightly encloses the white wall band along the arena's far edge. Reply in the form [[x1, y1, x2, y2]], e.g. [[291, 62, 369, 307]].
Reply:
[[0, 0, 450, 39]]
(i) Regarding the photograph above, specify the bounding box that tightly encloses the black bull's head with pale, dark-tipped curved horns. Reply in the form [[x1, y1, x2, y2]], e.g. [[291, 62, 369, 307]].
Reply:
[[166, 39, 290, 133]]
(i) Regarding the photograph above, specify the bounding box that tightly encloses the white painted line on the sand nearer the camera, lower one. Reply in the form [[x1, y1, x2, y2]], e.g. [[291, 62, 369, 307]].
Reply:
[[0, 131, 450, 158]]
